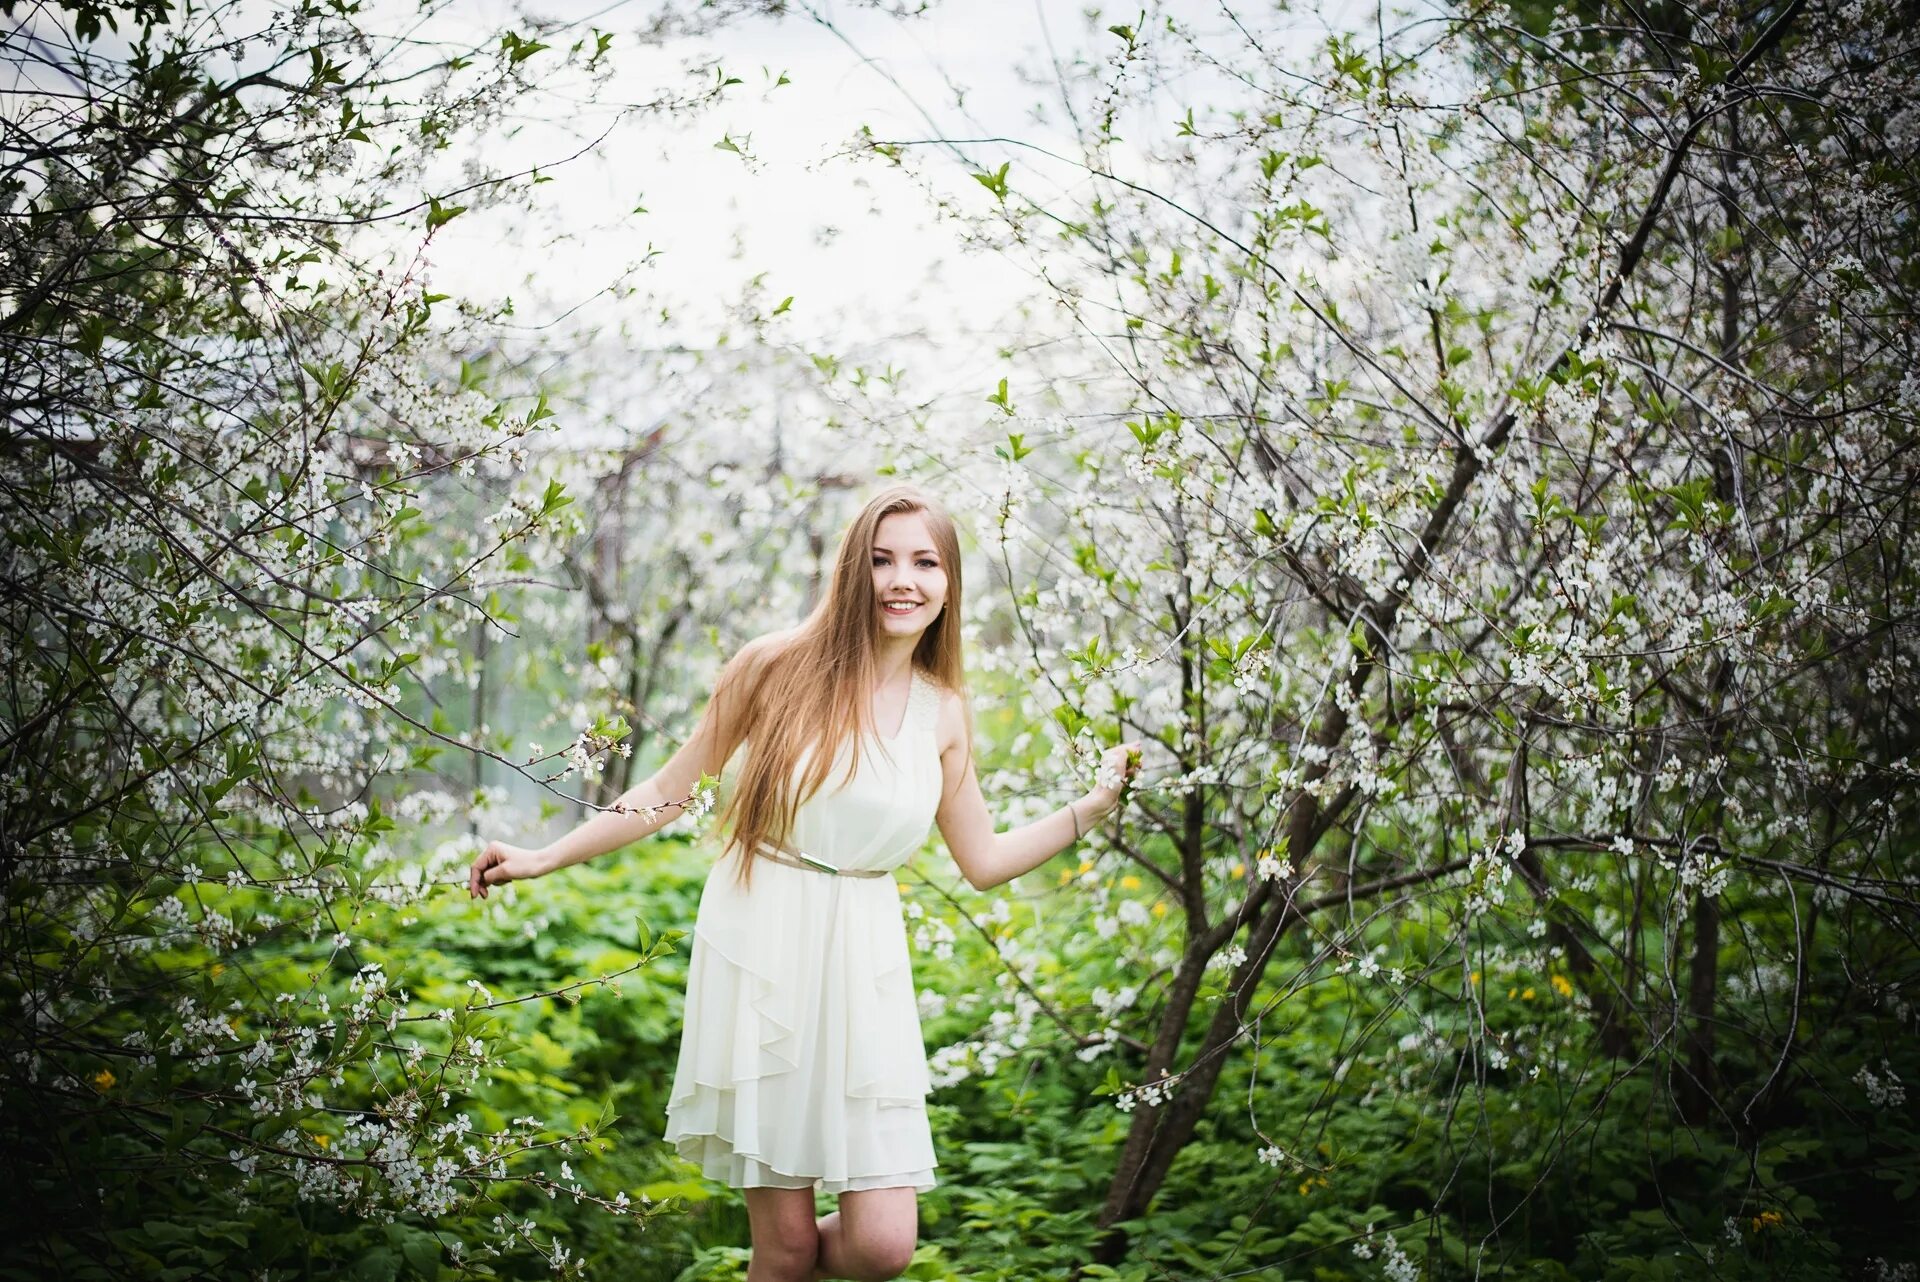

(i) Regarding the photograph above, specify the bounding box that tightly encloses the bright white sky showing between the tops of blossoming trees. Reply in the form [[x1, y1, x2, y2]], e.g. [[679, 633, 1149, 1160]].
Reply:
[[11, 0, 1338, 445]]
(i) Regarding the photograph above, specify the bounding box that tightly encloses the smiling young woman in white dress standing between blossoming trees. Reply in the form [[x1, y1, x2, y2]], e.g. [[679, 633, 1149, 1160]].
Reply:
[[468, 486, 1139, 1282]]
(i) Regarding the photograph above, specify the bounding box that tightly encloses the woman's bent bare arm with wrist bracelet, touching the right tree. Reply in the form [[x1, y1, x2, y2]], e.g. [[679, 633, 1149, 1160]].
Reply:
[[933, 691, 1139, 890]]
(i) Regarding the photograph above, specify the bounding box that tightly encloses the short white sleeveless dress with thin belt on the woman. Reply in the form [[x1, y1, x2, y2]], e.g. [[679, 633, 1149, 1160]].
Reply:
[[664, 668, 941, 1194]]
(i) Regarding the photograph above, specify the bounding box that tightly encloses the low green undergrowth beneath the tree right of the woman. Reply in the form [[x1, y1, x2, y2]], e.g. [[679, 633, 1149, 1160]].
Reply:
[[879, 794, 1920, 1282]]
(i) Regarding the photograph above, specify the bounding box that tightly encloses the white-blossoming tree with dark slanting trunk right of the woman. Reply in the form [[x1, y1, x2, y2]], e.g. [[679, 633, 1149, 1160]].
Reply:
[[848, 2, 1920, 1276]]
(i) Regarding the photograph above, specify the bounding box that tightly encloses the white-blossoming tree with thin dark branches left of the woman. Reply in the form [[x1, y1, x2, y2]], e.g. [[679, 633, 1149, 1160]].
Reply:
[[0, 0, 821, 1276]]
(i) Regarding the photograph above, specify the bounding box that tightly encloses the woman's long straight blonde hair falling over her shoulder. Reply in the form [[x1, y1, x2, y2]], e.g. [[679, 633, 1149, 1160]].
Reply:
[[708, 486, 972, 887]]
